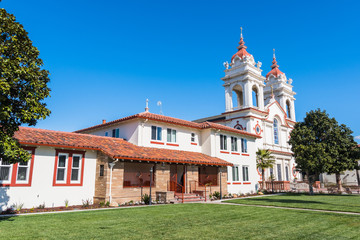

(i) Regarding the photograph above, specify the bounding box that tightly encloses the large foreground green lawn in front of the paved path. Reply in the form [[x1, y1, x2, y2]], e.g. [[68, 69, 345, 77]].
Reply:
[[0, 203, 360, 239]]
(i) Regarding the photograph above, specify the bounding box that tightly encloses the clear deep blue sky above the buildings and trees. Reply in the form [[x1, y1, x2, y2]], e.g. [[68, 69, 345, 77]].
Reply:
[[0, 0, 360, 142]]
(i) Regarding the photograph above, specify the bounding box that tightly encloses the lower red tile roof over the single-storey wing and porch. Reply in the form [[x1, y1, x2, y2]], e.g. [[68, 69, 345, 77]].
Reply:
[[14, 127, 232, 166]]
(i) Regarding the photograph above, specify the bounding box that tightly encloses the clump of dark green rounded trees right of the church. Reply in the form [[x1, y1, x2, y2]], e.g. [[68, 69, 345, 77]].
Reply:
[[289, 109, 356, 193]]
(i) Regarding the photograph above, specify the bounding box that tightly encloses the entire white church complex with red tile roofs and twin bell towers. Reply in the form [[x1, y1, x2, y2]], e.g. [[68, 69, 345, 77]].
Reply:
[[0, 31, 301, 209]]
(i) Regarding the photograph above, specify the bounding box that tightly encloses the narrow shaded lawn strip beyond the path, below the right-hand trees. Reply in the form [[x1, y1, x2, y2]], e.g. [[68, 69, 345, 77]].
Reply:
[[226, 193, 360, 213]]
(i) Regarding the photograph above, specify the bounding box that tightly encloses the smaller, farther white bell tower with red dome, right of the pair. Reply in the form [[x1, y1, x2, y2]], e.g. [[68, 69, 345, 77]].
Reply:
[[264, 49, 296, 121]]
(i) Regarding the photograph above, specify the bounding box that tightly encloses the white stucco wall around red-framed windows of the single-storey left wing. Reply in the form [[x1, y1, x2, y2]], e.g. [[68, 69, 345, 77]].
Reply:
[[0, 144, 97, 210]]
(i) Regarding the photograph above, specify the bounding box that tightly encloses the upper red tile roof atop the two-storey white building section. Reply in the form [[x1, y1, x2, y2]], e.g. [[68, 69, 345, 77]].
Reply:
[[75, 112, 261, 138]]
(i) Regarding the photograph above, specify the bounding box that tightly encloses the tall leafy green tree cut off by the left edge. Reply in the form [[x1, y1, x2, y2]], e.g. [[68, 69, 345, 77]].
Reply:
[[0, 9, 50, 163]]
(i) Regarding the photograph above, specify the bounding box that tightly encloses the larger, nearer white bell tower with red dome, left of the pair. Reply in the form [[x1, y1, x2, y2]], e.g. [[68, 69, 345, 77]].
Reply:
[[222, 28, 265, 112]]
